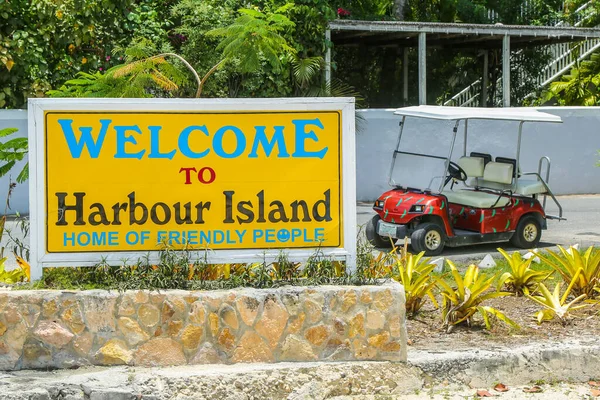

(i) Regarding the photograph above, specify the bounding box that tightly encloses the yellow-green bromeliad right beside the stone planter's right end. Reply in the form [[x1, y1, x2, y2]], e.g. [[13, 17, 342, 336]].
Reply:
[[392, 242, 439, 317]]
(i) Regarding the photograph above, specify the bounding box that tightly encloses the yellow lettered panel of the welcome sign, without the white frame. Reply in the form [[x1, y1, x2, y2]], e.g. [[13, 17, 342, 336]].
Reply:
[[44, 110, 343, 253]]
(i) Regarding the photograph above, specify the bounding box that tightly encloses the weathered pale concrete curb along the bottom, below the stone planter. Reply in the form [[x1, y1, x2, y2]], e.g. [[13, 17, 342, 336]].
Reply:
[[0, 338, 600, 400]]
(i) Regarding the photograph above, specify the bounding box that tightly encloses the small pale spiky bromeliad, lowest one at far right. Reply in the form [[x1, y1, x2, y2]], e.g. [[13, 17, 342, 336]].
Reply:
[[525, 270, 587, 325]]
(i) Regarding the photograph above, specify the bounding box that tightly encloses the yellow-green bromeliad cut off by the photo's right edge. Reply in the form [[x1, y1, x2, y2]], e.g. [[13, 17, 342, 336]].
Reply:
[[536, 246, 600, 298]]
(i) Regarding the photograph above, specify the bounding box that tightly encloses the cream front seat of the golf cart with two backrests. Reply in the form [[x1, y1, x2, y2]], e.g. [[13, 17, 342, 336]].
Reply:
[[442, 157, 513, 208]]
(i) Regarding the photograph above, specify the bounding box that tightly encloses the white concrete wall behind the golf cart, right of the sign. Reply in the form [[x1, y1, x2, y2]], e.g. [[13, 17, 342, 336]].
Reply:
[[356, 107, 600, 201]]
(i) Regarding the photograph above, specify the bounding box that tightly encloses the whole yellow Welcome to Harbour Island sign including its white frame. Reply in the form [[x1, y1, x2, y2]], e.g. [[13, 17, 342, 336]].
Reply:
[[29, 98, 355, 280]]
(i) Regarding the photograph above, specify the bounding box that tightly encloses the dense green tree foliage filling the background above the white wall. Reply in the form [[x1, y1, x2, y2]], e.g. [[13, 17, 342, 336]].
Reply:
[[0, 0, 599, 108]]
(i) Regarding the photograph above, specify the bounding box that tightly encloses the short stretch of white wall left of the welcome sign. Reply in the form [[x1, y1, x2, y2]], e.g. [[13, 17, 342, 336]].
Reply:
[[0, 110, 29, 215]]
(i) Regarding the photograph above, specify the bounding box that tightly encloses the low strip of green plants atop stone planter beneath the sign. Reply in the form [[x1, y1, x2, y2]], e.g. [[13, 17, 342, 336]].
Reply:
[[25, 242, 380, 291]]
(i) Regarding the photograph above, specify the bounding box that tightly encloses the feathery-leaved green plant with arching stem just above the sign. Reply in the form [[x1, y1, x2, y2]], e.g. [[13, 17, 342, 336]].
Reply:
[[49, 4, 302, 97]]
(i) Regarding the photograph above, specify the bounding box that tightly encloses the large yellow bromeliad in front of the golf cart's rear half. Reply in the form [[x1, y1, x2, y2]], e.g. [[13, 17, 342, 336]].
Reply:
[[438, 260, 519, 333]]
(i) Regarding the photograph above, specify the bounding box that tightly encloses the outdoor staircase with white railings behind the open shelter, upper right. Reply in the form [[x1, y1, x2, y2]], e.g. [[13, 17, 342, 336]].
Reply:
[[443, 0, 600, 107]]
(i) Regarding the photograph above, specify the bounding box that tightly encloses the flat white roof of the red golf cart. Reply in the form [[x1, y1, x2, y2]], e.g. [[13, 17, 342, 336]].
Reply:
[[394, 106, 562, 122]]
